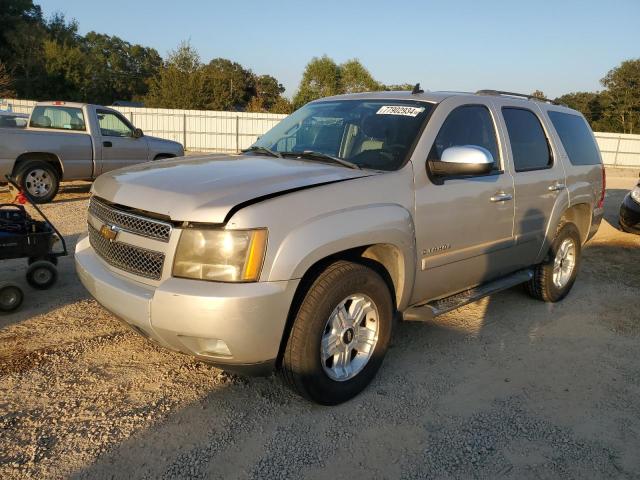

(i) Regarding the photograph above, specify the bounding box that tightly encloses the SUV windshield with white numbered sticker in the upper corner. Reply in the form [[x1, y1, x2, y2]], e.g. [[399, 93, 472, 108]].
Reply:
[[253, 100, 433, 170]]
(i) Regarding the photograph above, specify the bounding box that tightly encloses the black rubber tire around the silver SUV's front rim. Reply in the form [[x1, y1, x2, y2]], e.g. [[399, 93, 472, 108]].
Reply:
[[282, 261, 393, 405]]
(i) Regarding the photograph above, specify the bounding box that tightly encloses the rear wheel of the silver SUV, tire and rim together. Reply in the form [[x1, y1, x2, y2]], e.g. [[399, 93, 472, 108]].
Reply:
[[526, 223, 581, 302]]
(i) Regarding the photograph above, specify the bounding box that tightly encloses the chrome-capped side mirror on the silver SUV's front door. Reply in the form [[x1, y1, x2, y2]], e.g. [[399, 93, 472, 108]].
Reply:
[[429, 145, 494, 177]]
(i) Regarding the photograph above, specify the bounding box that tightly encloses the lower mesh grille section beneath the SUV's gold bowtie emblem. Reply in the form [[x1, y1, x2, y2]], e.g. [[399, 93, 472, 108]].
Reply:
[[88, 224, 164, 280]]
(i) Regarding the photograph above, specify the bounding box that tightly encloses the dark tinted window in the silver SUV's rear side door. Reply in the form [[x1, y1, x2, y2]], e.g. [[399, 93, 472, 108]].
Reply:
[[502, 107, 553, 172]]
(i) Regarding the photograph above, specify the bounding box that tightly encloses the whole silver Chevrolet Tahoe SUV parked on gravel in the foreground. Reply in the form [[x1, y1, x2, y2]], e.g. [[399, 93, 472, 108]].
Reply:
[[76, 86, 604, 404]]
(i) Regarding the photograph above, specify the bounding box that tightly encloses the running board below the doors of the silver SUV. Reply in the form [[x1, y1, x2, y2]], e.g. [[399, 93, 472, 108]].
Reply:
[[402, 269, 533, 322]]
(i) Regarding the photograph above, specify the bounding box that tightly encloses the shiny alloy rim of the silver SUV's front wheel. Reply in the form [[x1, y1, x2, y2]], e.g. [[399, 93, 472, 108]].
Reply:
[[320, 293, 380, 382]]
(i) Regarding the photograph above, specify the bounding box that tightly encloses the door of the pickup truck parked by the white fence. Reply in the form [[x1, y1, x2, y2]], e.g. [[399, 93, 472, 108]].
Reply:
[[96, 110, 149, 174]]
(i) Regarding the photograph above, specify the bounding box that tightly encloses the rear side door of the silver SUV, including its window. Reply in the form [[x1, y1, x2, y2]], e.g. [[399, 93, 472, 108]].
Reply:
[[500, 103, 566, 267]]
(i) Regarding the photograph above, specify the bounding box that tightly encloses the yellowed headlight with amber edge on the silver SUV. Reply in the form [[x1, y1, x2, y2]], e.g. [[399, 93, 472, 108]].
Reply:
[[173, 229, 267, 282]]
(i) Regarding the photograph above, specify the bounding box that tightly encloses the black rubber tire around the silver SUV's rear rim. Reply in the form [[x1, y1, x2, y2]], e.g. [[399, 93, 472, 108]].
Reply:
[[525, 223, 582, 302]]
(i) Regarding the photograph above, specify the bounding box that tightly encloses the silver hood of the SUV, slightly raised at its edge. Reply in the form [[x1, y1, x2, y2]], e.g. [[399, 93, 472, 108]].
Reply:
[[93, 155, 378, 223]]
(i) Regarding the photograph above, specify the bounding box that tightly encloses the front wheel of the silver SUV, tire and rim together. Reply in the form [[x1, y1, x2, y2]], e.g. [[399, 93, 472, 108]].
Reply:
[[282, 261, 393, 405]]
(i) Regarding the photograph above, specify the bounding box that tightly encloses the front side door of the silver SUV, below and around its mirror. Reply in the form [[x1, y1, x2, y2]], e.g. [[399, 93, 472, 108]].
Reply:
[[412, 97, 514, 303]]
